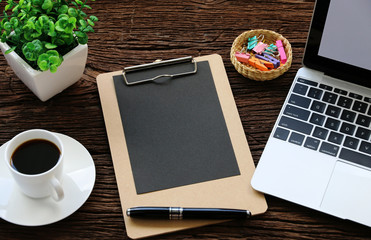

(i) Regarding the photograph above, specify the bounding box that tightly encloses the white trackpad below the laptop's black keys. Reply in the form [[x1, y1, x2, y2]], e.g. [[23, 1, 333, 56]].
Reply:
[[320, 161, 371, 226]]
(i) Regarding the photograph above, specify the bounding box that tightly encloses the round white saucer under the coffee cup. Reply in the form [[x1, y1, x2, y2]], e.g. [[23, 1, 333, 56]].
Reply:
[[0, 133, 95, 226]]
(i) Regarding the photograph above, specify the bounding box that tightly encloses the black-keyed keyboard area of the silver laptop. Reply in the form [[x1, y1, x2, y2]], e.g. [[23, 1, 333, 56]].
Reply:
[[273, 78, 371, 168]]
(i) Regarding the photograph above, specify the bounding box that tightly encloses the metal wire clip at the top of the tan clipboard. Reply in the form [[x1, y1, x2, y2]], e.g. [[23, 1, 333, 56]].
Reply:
[[122, 56, 197, 86]]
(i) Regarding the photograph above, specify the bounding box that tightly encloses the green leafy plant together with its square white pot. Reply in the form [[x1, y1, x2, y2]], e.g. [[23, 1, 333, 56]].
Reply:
[[0, 0, 98, 101]]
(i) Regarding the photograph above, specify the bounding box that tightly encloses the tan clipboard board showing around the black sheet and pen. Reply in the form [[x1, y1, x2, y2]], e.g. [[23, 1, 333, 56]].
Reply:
[[97, 54, 267, 239]]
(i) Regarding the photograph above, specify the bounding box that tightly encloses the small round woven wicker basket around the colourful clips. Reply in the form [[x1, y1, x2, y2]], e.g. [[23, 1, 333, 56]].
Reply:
[[230, 29, 292, 81]]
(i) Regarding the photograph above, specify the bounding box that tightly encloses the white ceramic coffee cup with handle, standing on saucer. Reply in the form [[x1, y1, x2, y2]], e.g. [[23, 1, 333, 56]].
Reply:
[[4, 129, 64, 201]]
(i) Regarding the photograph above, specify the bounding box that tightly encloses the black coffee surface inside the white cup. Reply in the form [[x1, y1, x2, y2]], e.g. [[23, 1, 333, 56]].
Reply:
[[10, 139, 61, 174]]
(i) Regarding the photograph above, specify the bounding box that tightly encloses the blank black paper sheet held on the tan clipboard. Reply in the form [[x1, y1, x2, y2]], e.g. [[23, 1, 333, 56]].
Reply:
[[113, 61, 240, 194]]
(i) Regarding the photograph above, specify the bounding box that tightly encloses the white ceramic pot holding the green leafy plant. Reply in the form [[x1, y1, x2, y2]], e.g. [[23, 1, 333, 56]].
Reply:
[[0, 42, 88, 101]]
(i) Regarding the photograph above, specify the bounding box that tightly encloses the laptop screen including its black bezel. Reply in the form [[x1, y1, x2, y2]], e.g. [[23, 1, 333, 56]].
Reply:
[[303, 0, 371, 87]]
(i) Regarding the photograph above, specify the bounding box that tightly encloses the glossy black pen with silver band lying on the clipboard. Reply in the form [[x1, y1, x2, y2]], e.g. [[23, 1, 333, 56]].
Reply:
[[126, 207, 251, 219]]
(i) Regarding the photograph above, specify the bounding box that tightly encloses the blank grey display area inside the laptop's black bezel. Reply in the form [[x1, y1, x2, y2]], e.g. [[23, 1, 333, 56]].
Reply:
[[318, 0, 371, 70]]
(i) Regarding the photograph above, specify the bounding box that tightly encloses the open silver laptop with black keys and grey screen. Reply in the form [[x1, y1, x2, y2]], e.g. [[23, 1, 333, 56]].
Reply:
[[251, 0, 371, 226]]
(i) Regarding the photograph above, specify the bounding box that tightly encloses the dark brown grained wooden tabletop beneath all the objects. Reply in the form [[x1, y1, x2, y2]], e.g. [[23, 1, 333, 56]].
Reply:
[[0, 0, 371, 240]]
